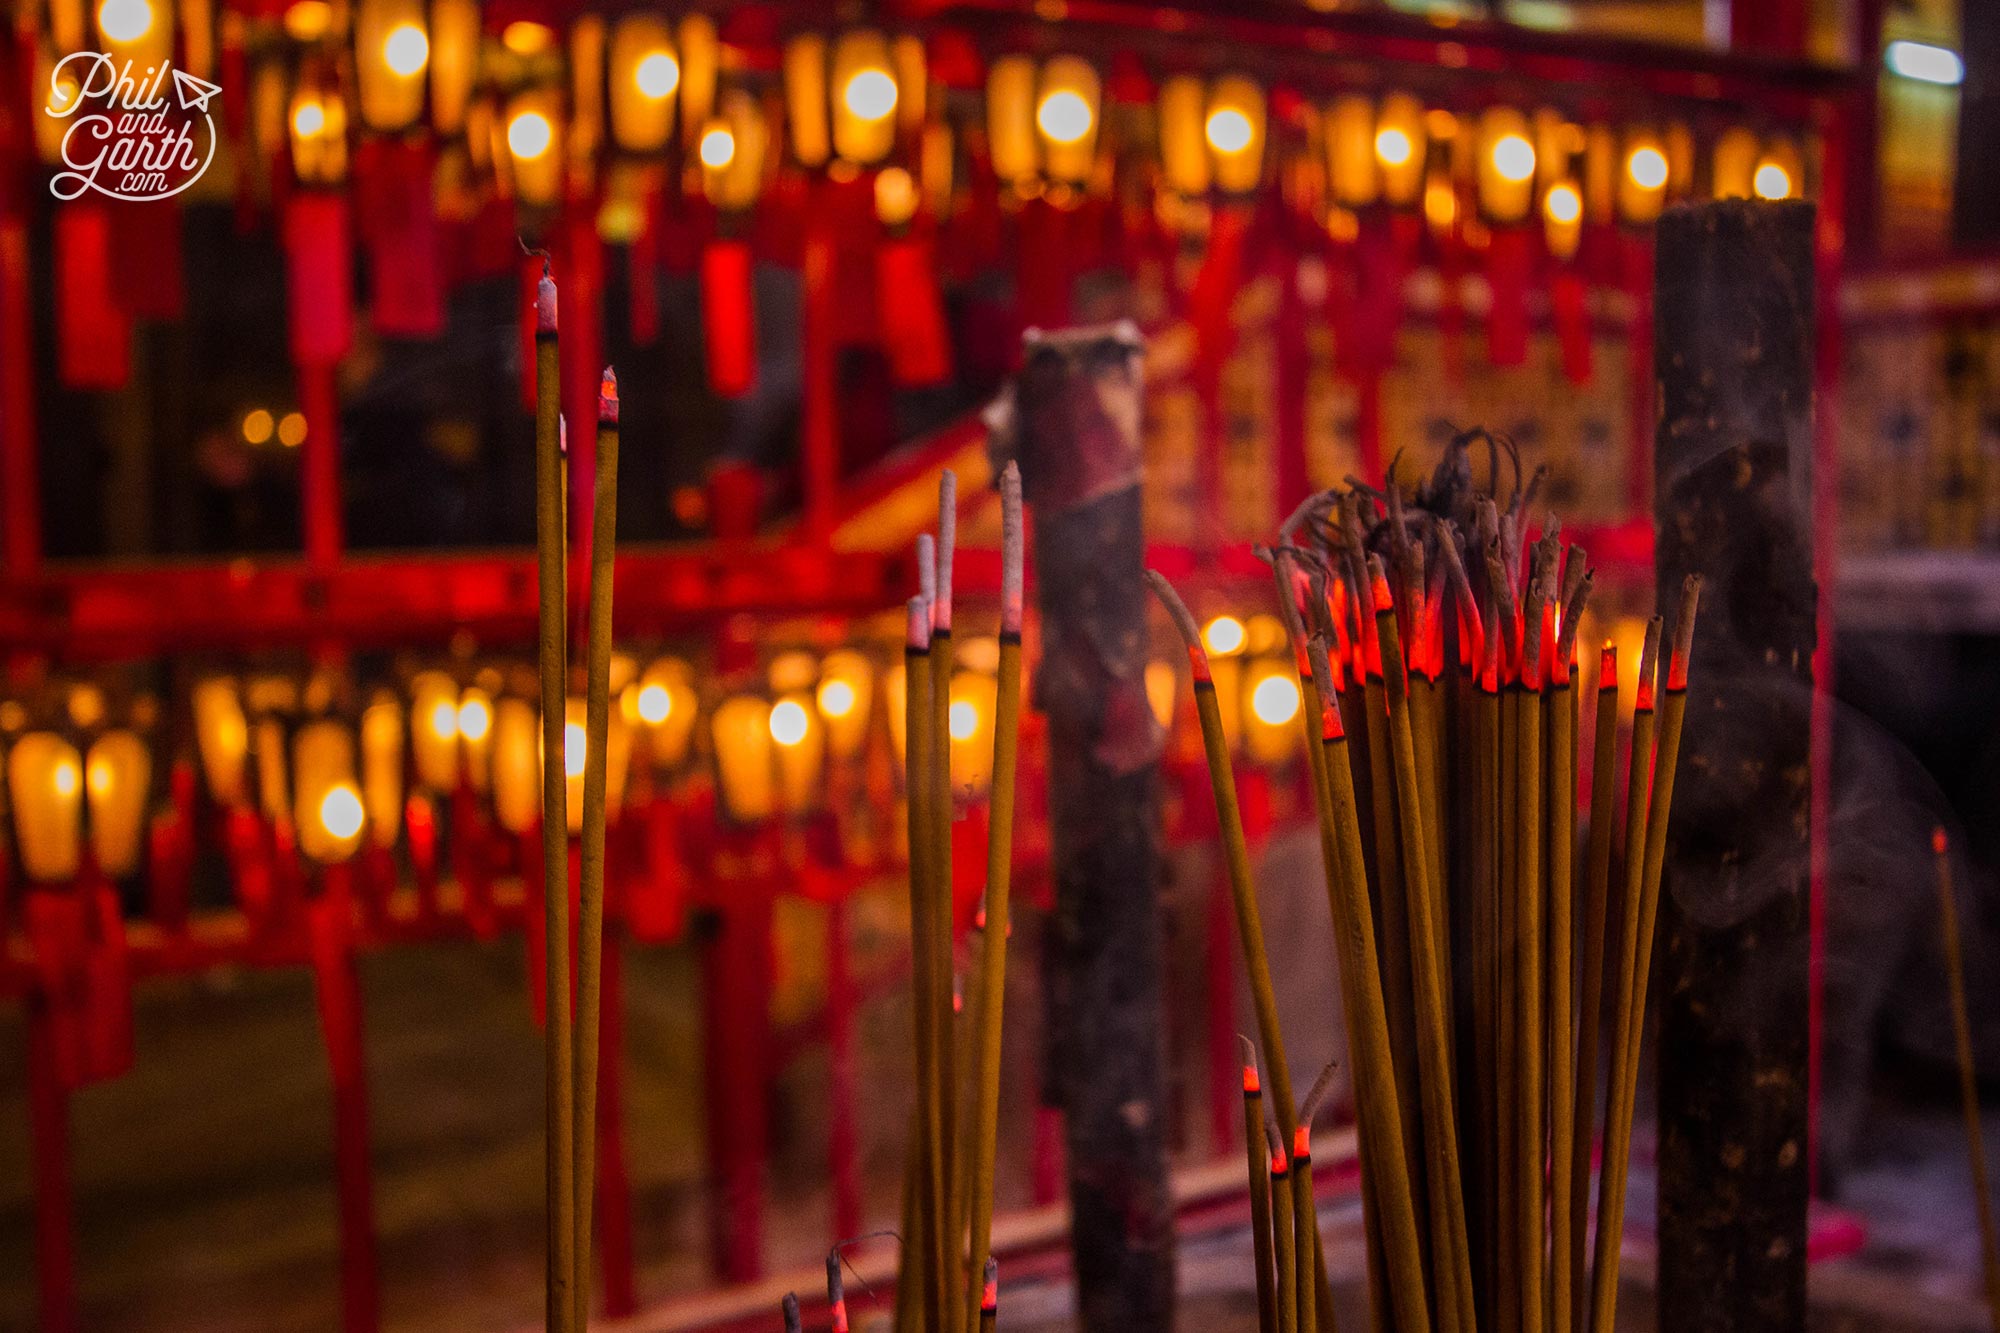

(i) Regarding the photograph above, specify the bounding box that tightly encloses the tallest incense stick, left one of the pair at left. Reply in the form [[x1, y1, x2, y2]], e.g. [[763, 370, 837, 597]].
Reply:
[[534, 264, 576, 1333]]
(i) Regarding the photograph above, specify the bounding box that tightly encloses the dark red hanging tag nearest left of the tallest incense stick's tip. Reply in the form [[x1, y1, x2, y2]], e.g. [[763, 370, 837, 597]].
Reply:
[[354, 140, 444, 338]]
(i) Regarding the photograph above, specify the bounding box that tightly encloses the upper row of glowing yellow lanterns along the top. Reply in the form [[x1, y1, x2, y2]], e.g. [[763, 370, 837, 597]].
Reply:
[[38, 0, 1806, 226]]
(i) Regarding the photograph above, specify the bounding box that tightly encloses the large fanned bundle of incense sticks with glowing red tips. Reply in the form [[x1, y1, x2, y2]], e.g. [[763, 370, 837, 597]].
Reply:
[[1150, 432, 1698, 1333]]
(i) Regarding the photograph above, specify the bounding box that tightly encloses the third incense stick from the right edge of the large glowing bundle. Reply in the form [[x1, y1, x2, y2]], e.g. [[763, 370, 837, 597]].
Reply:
[[1568, 640, 1618, 1323]]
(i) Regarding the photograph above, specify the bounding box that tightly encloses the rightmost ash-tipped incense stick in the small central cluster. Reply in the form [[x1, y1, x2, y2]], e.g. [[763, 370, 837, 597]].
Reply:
[[968, 462, 1024, 1323]]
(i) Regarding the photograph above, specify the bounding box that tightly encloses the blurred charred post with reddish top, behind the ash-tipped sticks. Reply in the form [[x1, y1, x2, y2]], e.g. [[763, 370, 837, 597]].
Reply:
[[994, 324, 1174, 1333]]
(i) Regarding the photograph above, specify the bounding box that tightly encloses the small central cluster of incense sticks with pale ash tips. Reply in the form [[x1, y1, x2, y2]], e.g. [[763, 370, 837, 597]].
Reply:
[[896, 462, 1024, 1333]]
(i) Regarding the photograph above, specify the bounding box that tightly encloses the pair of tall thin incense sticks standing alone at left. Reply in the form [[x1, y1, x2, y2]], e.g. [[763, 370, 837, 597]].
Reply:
[[534, 260, 618, 1333]]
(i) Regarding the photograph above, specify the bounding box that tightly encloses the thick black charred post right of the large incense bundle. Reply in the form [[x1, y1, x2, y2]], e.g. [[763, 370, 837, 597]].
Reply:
[[1654, 200, 1816, 1331]]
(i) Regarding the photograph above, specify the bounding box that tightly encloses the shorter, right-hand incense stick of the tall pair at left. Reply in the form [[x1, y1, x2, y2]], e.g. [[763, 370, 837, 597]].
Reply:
[[572, 366, 618, 1329]]
